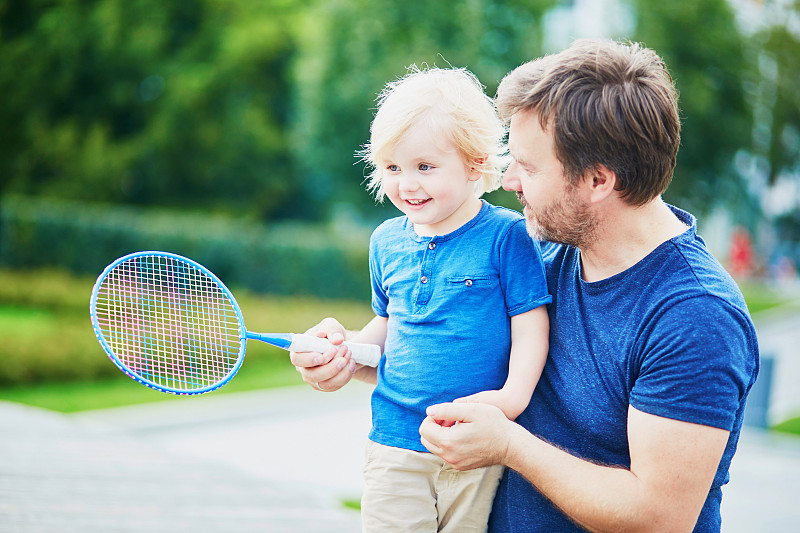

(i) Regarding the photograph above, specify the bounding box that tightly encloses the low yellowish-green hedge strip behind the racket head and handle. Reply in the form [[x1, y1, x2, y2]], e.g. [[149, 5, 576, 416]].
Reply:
[[0, 268, 372, 386]]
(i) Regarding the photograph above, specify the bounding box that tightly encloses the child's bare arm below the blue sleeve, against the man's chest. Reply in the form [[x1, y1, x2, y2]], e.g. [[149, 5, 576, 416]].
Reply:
[[456, 305, 550, 420]]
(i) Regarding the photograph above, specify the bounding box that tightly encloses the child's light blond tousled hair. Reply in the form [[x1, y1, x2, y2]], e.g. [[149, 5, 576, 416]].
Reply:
[[359, 65, 505, 202]]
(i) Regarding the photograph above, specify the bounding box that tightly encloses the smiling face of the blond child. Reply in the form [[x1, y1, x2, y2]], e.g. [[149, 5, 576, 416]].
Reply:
[[380, 121, 481, 237]]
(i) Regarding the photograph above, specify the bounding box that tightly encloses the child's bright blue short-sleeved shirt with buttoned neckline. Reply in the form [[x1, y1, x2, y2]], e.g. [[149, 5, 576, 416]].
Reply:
[[369, 201, 551, 452]]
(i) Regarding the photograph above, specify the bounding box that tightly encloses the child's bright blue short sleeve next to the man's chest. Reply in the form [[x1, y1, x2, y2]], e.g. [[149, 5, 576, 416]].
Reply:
[[500, 219, 553, 316]]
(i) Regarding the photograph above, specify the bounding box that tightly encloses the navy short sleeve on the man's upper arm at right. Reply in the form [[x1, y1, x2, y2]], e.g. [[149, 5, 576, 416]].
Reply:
[[630, 295, 758, 431]]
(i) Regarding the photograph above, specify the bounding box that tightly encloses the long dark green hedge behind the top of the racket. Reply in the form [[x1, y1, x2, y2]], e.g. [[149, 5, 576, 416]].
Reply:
[[0, 196, 369, 300]]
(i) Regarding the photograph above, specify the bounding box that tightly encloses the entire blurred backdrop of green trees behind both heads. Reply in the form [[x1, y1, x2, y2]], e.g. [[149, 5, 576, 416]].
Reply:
[[0, 0, 800, 235]]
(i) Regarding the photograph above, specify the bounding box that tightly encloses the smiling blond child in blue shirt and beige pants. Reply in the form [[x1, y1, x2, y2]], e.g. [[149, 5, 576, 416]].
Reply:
[[304, 68, 552, 532]]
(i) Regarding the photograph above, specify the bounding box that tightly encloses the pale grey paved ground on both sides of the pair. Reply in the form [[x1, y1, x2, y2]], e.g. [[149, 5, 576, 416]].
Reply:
[[0, 294, 800, 533]]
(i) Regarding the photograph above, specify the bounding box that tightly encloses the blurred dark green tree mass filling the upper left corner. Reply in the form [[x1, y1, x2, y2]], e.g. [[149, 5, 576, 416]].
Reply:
[[0, 0, 299, 217]]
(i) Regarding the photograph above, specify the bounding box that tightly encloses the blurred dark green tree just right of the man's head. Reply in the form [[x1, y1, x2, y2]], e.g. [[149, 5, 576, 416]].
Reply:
[[632, 0, 752, 214]]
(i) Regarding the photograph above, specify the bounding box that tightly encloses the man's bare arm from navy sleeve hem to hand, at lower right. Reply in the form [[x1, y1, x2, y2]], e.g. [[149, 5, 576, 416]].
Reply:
[[420, 403, 716, 532]]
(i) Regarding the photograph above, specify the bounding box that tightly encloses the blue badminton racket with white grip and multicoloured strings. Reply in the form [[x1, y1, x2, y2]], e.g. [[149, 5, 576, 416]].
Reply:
[[89, 251, 381, 394]]
